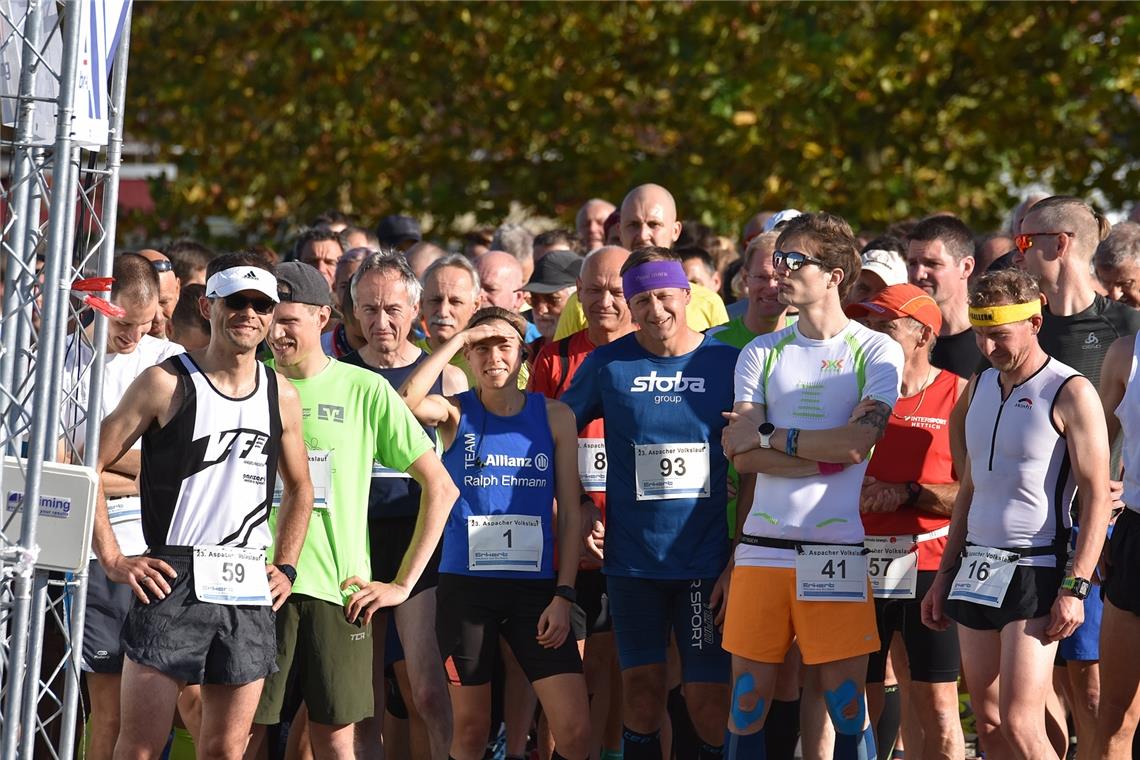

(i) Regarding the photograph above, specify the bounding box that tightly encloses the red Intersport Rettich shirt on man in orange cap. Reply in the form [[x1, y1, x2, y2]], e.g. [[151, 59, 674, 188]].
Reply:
[[863, 369, 958, 570]]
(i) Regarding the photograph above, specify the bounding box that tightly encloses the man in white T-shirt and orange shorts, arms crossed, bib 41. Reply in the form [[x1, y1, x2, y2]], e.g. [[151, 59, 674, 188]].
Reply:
[[724, 213, 903, 760]]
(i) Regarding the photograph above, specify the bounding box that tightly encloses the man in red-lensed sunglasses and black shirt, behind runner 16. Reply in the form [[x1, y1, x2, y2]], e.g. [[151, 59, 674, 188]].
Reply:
[[1013, 196, 1140, 746]]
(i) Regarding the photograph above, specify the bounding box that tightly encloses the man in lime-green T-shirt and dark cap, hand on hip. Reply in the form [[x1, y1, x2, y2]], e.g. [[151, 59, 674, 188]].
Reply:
[[252, 262, 458, 758]]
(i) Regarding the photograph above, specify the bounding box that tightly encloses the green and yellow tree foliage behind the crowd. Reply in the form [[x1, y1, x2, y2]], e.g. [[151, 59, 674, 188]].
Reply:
[[127, 2, 1140, 238]]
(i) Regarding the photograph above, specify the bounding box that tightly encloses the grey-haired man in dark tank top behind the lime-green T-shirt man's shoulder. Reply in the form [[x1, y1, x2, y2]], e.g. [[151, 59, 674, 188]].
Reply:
[[343, 251, 467, 758]]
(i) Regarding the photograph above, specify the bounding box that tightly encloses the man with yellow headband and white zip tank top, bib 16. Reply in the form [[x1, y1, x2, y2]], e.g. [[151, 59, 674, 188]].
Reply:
[[922, 270, 1109, 758]]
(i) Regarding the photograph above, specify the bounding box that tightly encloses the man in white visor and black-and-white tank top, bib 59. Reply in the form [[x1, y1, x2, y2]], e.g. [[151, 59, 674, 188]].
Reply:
[[93, 254, 312, 758]]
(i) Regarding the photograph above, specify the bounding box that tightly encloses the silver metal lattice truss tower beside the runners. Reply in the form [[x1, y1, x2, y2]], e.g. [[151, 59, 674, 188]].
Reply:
[[0, 0, 130, 760]]
